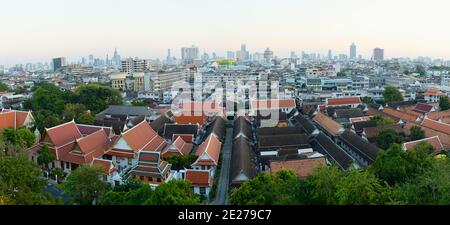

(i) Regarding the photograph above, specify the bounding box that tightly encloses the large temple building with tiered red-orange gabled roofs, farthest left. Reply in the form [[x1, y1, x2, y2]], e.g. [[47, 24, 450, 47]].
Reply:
[[29, 121, 121, 185]]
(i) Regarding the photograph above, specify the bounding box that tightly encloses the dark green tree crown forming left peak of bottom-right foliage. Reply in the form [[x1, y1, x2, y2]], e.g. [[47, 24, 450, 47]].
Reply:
[[370, 144, 409, 185]]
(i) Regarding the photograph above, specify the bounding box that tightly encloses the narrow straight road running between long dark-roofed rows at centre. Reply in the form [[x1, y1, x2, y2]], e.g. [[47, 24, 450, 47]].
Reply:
[[211, 128, 233, 205]]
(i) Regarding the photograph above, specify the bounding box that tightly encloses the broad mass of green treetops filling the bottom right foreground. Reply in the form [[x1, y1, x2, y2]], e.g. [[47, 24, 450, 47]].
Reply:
[[230, 143, 450, 205]]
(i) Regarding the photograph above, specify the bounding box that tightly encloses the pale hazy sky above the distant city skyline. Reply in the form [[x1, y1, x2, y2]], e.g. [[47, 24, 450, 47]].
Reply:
[[0, 0, 450, 65]]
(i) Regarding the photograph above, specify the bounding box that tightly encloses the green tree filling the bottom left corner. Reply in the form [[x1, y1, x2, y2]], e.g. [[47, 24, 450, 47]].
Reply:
[[0, 156, 59, 205]]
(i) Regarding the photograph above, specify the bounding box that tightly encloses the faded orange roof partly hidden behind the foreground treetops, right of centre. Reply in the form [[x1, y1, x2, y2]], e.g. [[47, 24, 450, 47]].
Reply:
[[270, 157, 326, 177]]
